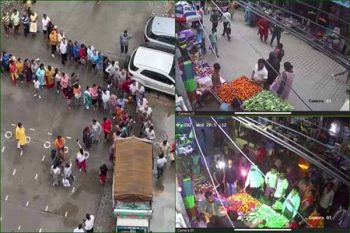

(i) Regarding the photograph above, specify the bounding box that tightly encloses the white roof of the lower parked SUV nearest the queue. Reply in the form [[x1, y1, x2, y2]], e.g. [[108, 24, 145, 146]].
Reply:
[[134, 46, 175, 75]]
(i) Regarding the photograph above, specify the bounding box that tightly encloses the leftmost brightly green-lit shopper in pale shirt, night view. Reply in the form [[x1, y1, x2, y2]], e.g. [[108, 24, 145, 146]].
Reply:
[[244, 165, 264, 198]]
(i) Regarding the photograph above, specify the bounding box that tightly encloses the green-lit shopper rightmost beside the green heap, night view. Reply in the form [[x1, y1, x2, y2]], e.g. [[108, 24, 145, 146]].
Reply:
[[282, 187, 300, 220]]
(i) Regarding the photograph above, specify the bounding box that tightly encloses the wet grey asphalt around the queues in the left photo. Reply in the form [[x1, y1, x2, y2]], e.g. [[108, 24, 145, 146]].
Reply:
[[0, 1, 175, 232]]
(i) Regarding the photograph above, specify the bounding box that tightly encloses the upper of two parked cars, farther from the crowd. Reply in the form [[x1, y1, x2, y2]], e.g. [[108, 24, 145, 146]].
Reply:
[[144, 16, 175, 49]]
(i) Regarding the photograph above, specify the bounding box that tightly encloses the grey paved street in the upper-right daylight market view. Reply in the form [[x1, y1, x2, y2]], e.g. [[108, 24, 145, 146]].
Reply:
[[204, 10, 349, 111]]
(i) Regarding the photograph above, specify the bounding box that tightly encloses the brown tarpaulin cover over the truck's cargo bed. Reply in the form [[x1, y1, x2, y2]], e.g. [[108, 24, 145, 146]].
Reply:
[[113, 137, 153, 202]]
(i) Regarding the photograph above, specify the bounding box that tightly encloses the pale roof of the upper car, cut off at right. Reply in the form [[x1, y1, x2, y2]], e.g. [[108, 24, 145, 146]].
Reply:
[[152, 16, 175, 37]]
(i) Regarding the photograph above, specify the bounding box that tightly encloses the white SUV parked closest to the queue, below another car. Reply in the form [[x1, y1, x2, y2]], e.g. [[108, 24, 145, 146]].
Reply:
[[128, 43, 175, 96]]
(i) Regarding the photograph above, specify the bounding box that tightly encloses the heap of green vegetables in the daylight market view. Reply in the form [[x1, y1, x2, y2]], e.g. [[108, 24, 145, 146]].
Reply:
[[243, 91, 294, 112]]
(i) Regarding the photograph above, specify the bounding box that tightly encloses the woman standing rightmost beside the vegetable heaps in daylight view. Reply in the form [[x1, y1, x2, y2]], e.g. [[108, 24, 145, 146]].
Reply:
[[270, 62, 295, 100]]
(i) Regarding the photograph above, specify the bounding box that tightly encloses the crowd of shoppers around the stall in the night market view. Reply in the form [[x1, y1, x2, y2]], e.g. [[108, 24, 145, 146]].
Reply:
[[193, 119, 350, 228]]
